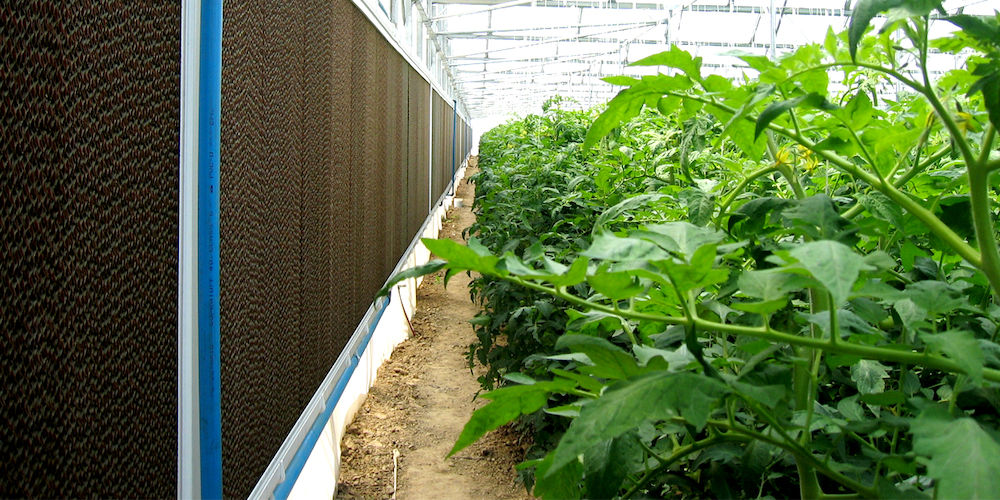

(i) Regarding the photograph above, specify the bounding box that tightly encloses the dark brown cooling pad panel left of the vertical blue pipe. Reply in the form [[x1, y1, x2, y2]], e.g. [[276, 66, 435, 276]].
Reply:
[[0, 0, 180, 498]]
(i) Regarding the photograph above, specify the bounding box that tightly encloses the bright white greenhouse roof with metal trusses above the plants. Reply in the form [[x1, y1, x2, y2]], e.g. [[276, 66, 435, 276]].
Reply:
[[415, 0, 995, 118]]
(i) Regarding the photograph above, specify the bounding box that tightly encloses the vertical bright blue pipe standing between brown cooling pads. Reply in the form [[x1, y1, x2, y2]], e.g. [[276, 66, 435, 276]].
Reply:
[[198, 0, 222, 499]]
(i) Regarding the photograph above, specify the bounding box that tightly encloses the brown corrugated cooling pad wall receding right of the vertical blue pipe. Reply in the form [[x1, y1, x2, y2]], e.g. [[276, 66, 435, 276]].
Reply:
[[220, 0, 451, 497]]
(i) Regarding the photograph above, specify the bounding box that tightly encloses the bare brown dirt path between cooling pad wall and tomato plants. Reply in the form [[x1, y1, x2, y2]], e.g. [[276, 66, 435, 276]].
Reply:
[[337, 164, 531, 500]]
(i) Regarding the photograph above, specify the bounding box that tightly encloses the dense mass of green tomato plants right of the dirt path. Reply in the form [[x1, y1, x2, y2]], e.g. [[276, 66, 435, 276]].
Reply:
[[382, 0, 1000, 498]]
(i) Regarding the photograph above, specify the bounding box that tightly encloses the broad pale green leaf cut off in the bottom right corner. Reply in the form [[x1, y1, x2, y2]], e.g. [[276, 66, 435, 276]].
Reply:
[[910, 407, 1000, 499]]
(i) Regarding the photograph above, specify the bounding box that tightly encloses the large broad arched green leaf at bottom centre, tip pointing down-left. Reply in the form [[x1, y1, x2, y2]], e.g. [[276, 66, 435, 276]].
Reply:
[[553, 372, 729, 474]]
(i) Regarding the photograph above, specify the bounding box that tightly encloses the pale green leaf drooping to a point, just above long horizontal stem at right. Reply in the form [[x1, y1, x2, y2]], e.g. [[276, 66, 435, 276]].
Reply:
[[789, 240, 868, 307]]
